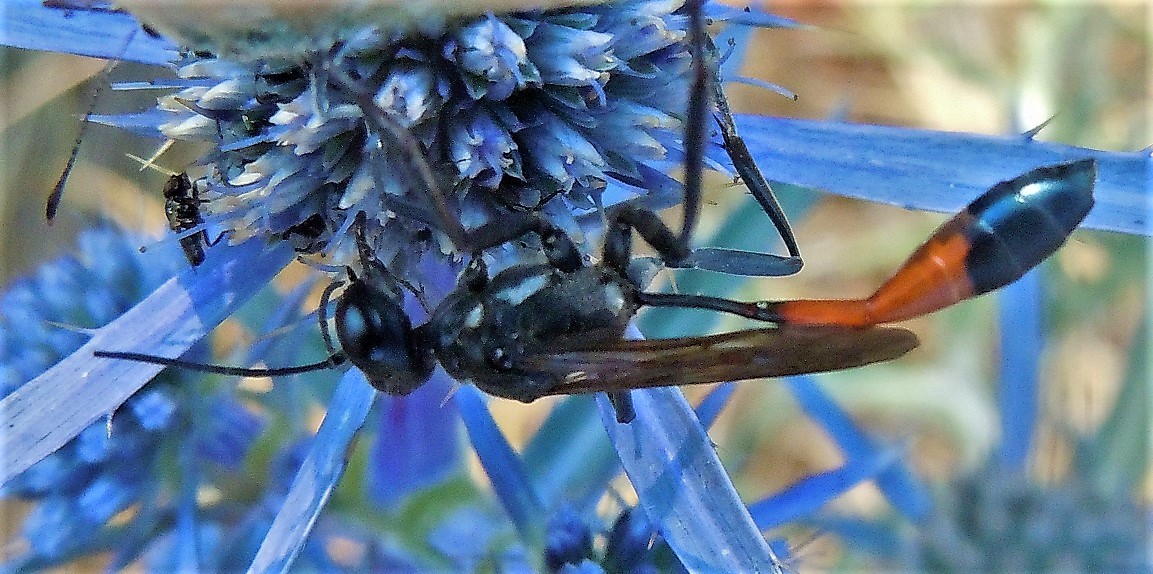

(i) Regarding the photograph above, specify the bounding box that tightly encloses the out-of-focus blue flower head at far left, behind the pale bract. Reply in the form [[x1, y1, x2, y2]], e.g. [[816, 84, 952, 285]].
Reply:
[[0, 225, 261, 567]]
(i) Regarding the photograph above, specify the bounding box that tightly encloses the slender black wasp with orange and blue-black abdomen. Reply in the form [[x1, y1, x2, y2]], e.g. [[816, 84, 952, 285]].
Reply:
[[96, 0, 1095, 422]]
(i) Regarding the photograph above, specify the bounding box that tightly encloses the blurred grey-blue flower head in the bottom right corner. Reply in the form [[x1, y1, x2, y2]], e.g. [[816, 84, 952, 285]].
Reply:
[[909, 467, 1151, 572]]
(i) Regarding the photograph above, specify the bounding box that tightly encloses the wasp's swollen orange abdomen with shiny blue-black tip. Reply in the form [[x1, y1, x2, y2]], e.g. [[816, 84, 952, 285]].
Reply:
[[768, 159, 1097, 327]]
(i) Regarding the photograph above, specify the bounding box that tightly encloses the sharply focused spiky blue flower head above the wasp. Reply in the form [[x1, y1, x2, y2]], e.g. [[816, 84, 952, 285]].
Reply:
[[130, 0, 691, 284]]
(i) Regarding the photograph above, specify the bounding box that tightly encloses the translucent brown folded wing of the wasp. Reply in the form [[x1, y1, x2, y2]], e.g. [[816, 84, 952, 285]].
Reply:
[[518, 327, 918, 394]]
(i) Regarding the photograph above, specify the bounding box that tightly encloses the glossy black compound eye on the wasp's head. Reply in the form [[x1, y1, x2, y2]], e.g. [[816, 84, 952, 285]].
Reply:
[[337, 281, 434, 394]]
